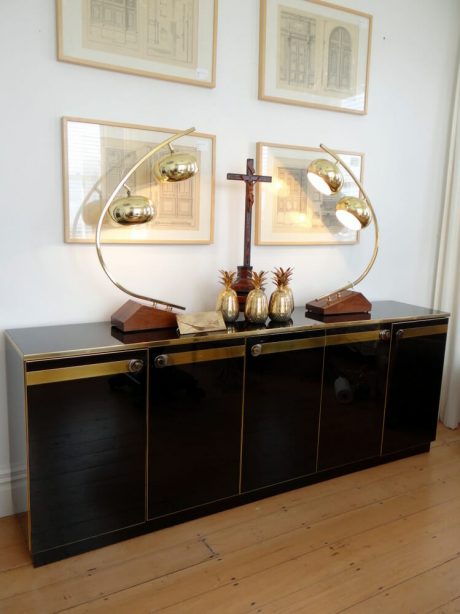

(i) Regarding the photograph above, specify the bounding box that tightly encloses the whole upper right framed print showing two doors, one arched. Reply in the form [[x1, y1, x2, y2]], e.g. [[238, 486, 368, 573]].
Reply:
[[259, 0, 372, 114]]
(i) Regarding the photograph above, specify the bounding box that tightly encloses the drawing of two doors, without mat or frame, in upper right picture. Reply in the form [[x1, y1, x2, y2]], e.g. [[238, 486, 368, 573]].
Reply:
[[277, 6, 359, 96]]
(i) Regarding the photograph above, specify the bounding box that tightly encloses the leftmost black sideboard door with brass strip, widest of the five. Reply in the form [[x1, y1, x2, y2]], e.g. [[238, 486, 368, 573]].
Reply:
[[26, 351, 148, 553]]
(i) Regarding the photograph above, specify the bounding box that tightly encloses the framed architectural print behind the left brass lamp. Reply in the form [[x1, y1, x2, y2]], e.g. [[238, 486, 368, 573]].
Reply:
[[62, 117, 215, 244]]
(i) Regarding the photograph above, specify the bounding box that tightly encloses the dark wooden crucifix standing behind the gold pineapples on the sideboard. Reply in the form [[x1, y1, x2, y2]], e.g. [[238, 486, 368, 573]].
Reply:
[[227, 158, 272, 311]]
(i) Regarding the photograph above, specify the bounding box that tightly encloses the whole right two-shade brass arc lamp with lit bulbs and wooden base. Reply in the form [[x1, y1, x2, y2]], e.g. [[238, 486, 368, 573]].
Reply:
[[306, 145, 379, 316]]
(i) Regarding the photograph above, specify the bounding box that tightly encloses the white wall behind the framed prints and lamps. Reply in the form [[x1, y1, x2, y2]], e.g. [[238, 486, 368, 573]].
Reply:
[[0, 0, 460, 515]]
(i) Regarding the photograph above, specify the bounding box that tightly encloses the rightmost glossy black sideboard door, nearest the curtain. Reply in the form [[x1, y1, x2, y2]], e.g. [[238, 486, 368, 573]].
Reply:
[[383, 320, 447, 454]]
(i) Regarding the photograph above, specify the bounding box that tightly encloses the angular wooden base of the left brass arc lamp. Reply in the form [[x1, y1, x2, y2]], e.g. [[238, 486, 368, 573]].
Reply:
[[112, 301, 177, 333]]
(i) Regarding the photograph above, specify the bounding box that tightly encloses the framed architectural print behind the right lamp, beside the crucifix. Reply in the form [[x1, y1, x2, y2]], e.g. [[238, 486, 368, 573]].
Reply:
[[255, 143, 364, 245]]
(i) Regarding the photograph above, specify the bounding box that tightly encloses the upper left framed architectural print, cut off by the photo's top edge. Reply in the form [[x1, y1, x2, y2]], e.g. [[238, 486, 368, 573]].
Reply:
[[56, 0, 218, 88]]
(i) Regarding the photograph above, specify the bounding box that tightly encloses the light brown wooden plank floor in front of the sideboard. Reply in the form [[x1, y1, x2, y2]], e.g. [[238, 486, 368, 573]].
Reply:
[[0, 426, 460, 614]]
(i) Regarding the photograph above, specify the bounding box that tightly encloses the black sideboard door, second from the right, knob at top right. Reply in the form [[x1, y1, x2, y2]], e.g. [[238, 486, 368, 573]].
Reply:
[[318, 326, 391, 471]]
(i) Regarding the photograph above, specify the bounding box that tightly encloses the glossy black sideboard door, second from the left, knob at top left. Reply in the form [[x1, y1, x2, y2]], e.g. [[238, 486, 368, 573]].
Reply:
[[148, 340, 244, 518]]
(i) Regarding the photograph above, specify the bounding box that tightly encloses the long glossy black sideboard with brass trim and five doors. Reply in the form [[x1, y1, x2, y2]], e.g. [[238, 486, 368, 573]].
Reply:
[[6, 301, 448, 565]]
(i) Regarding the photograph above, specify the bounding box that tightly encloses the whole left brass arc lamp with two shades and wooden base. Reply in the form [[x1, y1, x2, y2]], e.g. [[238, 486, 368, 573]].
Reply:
[[96, 128, 198, 332]]
